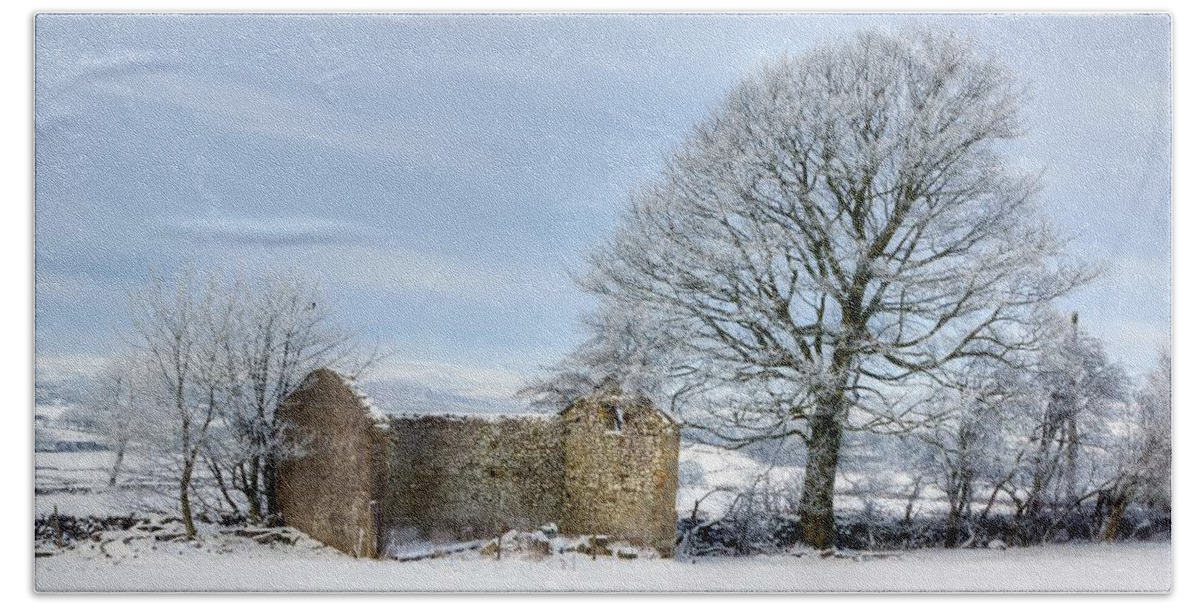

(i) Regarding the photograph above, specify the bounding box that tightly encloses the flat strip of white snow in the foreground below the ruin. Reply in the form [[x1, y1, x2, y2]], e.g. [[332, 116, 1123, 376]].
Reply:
[[34, 538, 1171, 592]]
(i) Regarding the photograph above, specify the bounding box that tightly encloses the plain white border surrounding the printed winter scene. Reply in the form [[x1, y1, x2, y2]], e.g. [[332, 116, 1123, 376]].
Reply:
[[7, 0, 1200, 606]]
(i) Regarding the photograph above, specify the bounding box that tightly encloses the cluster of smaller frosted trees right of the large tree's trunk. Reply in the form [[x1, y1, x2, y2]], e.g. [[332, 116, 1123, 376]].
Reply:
[[900, 315, 1171, 547]]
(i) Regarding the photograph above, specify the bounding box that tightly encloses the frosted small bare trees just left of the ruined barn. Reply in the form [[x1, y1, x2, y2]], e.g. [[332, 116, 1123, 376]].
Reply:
[[79, 271, 378, 536]]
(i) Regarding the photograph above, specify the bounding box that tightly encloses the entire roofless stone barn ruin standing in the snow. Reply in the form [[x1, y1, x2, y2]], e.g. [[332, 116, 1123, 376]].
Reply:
[[277, 369, 679, 556]]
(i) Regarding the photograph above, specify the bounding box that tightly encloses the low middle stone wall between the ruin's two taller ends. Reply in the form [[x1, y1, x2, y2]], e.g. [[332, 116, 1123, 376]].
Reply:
[[383, 416, 563, 542]]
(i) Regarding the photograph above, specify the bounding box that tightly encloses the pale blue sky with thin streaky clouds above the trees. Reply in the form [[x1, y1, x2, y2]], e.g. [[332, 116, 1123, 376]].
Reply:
[[34, 14, 1172, 410]]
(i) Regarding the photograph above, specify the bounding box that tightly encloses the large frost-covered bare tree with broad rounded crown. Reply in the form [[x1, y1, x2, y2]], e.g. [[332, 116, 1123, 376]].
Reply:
[[584, 31, 1090, 548]]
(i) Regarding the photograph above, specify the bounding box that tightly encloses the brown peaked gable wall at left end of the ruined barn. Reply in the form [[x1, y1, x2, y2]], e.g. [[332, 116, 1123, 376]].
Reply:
[[276, 369, 386, 556]]
